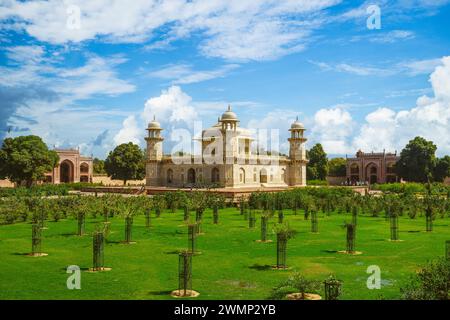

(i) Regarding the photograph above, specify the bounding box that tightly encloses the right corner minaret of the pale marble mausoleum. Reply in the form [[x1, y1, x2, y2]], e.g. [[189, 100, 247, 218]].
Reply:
[[288, 117, 308, 186]]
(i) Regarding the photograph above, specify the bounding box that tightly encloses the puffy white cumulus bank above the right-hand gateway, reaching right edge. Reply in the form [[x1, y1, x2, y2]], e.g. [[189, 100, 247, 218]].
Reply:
[[312, 57, 450, 155]]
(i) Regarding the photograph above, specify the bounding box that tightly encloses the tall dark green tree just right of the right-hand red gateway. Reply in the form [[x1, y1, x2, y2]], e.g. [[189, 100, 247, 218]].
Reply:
[[395, 137, 436, 182]]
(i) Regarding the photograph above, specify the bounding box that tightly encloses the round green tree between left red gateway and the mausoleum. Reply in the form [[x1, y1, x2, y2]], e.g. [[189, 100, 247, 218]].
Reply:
[[105, 142, 145, 185]]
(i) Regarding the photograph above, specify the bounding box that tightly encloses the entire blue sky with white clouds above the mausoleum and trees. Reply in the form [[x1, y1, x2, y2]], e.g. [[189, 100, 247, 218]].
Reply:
[[0, 0, 450, 158]]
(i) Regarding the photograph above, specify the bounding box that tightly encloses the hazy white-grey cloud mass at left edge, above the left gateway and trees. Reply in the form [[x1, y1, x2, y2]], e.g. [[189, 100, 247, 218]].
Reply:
[[0, 46, 135, 155]]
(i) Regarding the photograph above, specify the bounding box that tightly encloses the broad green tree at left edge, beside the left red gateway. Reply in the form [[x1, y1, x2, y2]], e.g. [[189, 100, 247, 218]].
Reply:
[[0, 136, 59, 187]]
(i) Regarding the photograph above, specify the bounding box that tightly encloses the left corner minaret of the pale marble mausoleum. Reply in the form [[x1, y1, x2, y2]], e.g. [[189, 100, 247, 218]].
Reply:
[[145, 116, 164, 186]]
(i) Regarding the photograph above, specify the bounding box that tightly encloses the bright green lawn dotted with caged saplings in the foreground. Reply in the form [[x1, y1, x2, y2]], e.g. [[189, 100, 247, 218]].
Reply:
[[0, 208, 450, 299]]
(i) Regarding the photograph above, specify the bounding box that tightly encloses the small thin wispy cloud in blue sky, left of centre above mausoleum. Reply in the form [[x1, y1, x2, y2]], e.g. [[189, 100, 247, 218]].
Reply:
[[149, 64, 239, 84]]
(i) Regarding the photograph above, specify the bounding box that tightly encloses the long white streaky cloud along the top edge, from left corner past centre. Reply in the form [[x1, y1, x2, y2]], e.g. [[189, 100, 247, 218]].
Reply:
[[0, 0, 340, 60]]
